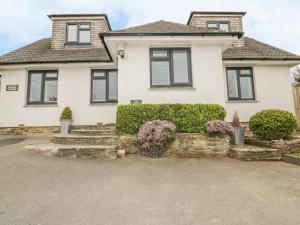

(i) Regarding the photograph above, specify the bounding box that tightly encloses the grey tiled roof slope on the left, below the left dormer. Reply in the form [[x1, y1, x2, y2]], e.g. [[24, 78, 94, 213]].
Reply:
[[0, 38, 110, 65]]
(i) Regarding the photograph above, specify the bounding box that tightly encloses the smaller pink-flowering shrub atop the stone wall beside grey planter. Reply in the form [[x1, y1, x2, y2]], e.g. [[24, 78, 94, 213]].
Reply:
[[206, 120, 233, 135]]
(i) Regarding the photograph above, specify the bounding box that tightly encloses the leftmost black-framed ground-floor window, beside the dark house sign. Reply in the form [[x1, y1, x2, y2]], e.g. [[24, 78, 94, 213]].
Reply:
[[27, 70, 58, 104]]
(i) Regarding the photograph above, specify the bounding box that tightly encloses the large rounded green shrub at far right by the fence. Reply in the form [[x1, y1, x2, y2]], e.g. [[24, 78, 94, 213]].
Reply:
[[249, 109, 297, 140]]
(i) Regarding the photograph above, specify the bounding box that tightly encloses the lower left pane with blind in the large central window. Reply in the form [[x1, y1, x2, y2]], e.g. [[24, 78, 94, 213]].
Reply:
[[151, 61, 170, 85]]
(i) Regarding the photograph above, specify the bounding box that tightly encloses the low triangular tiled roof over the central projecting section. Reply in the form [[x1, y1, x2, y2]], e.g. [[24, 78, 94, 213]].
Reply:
[[108, 20, 224, 33]]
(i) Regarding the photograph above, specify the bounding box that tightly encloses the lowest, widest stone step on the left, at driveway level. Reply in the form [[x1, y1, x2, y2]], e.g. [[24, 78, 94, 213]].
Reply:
[[25, 143, 118, 159]]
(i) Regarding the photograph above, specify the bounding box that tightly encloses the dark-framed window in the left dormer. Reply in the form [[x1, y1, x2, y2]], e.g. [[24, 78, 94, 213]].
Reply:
[[67, 23, 91, 44]]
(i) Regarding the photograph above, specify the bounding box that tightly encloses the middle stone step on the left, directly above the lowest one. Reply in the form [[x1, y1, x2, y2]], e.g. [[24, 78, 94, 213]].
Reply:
[[52, 134, 118, 145]]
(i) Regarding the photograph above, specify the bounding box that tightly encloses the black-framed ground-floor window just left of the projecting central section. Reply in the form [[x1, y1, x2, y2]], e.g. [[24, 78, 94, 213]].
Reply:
[[91, 70, 118, 103]]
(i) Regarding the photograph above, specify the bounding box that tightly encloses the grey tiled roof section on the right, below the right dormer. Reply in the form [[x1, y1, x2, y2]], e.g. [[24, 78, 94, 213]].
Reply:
[[223, 37, 300, 60]]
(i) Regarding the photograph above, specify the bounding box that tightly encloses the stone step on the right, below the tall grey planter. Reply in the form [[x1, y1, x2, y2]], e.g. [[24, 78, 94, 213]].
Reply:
[[229, 145, 282, 161]]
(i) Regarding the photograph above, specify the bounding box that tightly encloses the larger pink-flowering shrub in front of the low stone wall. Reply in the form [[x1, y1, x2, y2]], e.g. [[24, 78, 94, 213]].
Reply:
[[137, 120, 176, 158]]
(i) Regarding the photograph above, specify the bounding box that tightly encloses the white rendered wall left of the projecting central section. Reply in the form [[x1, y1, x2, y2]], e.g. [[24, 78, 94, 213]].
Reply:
[[0, 66, 117, 127]]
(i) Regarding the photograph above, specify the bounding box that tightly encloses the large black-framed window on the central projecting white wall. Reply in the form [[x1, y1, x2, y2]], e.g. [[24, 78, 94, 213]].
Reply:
[[150, 48, 192, 87]]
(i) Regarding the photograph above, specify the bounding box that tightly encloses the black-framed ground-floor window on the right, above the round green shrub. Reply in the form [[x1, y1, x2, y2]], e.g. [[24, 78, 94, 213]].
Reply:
[[226, 67, 255, 101]]
